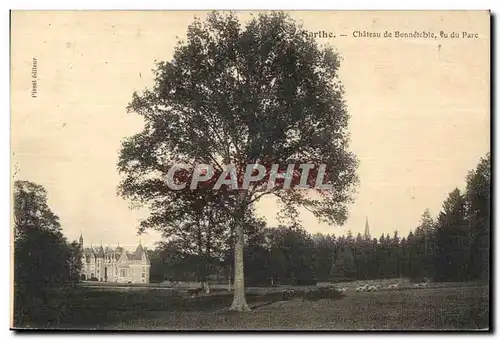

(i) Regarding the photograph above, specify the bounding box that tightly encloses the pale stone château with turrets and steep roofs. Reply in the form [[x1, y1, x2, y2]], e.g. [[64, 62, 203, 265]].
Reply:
[[79, 235, 151, 283]]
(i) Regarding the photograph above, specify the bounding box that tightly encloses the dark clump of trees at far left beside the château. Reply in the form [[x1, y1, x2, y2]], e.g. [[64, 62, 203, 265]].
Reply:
[[14, 181, 81, 327]]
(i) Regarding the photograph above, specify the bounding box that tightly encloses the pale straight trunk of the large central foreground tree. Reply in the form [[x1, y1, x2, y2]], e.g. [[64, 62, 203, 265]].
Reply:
[[229, 191, 250, 312]]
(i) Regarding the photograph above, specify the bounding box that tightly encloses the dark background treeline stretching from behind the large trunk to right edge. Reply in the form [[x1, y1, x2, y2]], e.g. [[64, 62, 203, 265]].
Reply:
[[150, 154, 491, 285]]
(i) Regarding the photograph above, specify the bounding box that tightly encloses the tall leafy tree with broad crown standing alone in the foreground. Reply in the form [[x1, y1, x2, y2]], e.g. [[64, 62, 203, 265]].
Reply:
[[119, 12, 357, 311]]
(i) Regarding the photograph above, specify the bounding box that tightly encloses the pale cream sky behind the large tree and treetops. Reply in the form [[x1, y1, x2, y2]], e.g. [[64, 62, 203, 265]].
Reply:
[[11, 11, 490, 246]]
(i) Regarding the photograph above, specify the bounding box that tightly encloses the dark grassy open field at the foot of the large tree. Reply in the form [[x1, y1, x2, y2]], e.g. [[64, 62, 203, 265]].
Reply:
[[14, 283, 489, 330]]
